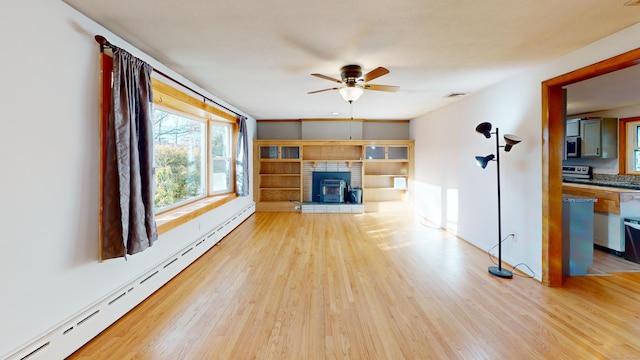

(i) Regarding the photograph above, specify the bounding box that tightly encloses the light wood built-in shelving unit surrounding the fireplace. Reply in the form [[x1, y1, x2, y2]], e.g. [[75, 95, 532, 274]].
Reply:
[[254, 140, 413, 212]]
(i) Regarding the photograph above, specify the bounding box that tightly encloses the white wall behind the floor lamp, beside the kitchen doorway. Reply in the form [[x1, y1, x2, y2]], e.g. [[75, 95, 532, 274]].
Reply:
[[411, 25, 640, 280]]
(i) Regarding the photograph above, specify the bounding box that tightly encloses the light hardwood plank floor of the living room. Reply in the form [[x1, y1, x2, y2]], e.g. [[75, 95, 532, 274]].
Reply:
[[70, 213, 640, 360]]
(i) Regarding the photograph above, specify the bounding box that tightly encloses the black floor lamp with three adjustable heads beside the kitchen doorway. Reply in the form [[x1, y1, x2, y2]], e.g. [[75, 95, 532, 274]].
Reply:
[[476, 122, 522, 279]]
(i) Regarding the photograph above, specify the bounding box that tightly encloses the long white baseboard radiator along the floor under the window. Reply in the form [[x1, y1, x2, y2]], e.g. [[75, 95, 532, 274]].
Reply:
[[5, 203, 255, 360]]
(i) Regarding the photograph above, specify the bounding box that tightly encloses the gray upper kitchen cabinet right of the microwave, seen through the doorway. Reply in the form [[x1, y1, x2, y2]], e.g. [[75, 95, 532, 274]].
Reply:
[[580, 118, 618, 159]]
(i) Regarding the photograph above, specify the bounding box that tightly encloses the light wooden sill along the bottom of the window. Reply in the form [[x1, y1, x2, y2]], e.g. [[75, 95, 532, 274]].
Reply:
[[156, 194, 237, 234]]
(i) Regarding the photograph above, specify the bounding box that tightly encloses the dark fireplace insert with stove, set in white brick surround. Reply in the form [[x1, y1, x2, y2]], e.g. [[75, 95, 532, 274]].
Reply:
[[311, 171, 351, 203]]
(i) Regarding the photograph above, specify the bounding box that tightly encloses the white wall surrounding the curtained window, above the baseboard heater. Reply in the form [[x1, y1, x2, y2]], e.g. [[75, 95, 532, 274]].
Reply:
[[0, 0, 256, 357]]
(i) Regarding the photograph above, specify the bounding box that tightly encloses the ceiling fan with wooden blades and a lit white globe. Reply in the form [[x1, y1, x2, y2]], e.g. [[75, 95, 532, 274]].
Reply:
[[308, 65, 400, 103]]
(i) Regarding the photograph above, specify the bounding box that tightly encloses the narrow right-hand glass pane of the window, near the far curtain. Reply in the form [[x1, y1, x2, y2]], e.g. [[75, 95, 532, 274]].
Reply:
[[209, 123, 233, 194]]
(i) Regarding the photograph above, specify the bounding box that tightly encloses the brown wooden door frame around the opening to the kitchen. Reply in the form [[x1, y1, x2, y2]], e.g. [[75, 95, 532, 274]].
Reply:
[[542, 48, 640, 286]]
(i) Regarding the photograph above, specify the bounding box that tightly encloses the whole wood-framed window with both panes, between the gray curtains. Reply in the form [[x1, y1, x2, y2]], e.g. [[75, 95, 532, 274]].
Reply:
[[153, 79, 238, 213]]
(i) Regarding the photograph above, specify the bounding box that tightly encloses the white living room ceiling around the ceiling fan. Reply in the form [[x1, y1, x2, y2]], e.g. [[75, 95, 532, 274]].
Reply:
[[64, 0, 640, 119]]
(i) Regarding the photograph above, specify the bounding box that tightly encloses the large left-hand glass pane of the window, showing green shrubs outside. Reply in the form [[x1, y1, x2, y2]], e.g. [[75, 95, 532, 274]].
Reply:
[[153, 107, 206, 211]]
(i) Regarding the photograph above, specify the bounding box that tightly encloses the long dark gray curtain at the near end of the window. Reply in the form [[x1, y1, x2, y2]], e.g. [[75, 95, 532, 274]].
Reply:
[[102, 48, 158, 260]]
